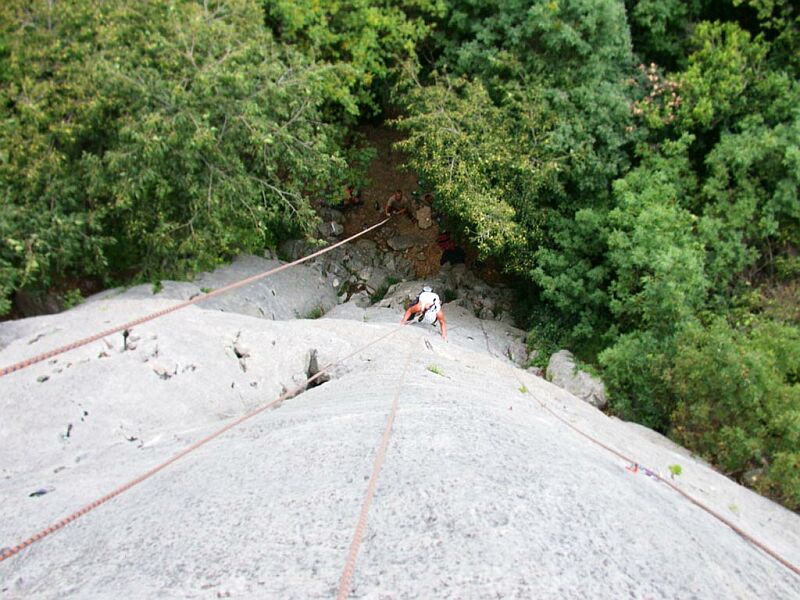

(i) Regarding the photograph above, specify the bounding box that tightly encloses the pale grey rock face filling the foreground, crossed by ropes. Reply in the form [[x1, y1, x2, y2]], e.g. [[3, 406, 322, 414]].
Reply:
[[0, 260, 800, 599]]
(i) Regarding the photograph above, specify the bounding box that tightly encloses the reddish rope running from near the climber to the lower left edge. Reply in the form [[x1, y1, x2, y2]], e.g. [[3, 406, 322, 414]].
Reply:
[[0, 326, 402, 562]]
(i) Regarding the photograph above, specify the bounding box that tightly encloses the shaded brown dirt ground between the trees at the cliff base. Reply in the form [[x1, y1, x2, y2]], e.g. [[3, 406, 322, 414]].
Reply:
[[344, 126, 442, 277]]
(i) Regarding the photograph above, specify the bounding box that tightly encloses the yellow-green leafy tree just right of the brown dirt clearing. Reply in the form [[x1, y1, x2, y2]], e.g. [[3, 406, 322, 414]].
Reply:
[[399, 78, 536, 260]]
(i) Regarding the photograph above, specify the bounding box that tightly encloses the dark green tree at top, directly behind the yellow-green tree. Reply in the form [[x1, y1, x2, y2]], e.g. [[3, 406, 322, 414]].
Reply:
[[424, 0, 633, 205]]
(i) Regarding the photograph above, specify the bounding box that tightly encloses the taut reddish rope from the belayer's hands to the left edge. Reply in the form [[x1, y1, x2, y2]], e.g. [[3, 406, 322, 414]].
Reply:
[[0, 218, 389, 377]]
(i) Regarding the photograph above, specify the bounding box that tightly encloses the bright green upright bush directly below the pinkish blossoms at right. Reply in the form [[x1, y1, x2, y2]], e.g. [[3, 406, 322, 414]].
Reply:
[[607, 139, 709, 337]]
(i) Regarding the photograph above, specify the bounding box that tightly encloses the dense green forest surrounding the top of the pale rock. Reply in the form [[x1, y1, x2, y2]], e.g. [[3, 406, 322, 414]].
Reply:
[[0, 0, 800, 510]]
